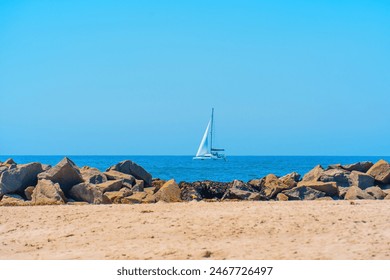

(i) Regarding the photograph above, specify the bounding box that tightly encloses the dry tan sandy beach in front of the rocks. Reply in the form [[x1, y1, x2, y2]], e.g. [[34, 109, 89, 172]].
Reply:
[[0, 200, 390, 259]]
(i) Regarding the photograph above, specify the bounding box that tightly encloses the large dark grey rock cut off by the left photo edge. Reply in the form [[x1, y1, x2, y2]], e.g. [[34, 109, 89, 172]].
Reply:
[[0, 162, 42, 196]]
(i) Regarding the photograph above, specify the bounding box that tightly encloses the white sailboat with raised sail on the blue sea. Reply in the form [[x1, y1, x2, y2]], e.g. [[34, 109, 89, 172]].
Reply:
[[193, 108, 226, 160]]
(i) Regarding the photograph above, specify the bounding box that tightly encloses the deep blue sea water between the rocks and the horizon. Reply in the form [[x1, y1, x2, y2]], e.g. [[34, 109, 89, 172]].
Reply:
[[0, 156, 390, 182]]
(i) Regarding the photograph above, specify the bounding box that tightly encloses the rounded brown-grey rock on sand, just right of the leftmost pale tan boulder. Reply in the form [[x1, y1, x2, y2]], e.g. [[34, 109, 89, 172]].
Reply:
[[69, 183, 111, 204]]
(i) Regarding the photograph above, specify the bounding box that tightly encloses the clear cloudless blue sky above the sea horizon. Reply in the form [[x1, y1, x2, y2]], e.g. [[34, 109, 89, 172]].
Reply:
[[0, 0, 390, 155]]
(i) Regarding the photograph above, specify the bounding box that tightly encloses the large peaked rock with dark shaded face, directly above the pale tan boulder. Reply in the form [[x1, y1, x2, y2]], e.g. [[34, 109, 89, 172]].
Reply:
[[38, 157, 83, 193]]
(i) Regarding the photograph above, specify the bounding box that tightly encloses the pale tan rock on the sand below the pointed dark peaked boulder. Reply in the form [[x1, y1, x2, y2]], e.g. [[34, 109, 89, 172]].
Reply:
[[31, 179, 67, 205]]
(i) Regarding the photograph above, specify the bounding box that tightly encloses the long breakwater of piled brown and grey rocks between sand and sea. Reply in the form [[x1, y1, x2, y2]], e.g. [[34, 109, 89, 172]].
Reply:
[[0, 158, 390, 206]]
